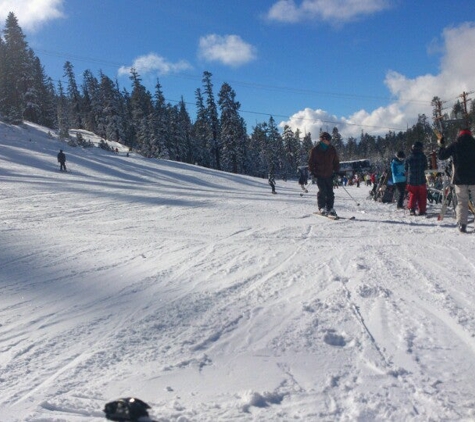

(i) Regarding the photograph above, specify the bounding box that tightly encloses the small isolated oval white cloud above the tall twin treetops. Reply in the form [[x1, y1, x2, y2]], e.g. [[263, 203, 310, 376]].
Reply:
[[198, 34, 256, 67]]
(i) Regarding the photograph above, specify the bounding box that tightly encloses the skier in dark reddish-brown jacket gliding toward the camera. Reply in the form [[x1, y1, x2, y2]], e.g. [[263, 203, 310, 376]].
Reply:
[[308, 132, 340, 216]]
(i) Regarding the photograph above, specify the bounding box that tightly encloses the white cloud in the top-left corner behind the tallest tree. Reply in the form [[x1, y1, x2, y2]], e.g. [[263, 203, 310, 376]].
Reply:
[[0, 0, 65, 31]]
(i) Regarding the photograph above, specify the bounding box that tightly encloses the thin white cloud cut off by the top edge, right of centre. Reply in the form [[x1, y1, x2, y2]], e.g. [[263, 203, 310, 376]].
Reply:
[[267, 0, 392, 23]]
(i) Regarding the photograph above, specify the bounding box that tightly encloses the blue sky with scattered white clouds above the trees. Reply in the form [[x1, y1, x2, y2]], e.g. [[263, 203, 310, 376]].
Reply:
[[0, 0, 475, 137]]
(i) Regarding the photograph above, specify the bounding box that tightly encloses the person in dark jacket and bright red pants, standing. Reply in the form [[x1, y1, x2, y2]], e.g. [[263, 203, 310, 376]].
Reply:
[[405, 141, 428, 215]]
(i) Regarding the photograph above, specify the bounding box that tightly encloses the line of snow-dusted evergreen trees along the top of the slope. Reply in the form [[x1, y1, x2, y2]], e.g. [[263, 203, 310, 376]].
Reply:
[[0, 13, 475, 177]]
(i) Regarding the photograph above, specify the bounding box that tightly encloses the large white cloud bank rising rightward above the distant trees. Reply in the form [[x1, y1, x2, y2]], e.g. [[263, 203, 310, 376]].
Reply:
[[280, 23, 475, 137]]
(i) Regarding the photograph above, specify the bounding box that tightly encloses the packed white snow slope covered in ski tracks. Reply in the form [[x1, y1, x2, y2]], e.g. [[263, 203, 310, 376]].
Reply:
[[0, 123, 475, 422]]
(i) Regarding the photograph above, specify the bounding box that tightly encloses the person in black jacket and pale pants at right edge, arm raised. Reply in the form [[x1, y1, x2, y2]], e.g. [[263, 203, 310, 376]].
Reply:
[[437, 128, 475, 233]]
